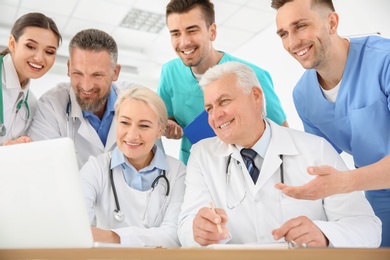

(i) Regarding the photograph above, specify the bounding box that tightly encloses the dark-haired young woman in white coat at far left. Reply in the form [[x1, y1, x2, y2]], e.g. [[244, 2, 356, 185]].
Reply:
[[0, 13, 62, 145]]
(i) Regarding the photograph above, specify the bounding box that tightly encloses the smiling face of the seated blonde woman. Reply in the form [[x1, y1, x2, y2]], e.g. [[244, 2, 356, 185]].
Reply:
[[116, 98, 163, 170]]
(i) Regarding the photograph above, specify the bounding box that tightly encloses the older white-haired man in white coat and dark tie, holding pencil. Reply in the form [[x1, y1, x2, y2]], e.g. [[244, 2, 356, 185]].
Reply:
[[178, 62, 381, 247]]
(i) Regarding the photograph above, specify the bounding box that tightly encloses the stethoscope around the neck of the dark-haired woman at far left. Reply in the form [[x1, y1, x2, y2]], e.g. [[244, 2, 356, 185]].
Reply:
[[0, 55, 30, 136]]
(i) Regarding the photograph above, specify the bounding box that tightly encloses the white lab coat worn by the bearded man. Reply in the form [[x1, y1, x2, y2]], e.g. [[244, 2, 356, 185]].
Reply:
[[29, 83, 124, 168]]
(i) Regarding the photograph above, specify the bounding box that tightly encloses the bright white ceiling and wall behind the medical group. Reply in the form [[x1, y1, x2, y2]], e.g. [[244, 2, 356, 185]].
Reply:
[[0, 0, 390, 168]]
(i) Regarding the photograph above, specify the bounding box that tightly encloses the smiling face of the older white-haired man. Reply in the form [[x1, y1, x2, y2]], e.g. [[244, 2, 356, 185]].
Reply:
[[204, 74, 264, 148]]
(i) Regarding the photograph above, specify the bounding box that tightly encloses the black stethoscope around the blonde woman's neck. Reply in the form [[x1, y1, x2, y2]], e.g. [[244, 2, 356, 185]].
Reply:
[[109, 160, 170, 223]]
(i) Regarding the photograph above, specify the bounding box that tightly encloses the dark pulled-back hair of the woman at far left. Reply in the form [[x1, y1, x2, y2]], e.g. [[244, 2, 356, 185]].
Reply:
[[0, 13, 62, 55]]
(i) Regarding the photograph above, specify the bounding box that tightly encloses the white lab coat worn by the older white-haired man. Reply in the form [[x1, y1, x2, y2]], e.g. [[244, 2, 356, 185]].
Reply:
[[178, 120, 382, 247]]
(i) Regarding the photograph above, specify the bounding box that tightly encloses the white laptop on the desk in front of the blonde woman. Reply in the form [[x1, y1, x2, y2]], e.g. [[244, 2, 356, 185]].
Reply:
[[0, 138, 94, 249]]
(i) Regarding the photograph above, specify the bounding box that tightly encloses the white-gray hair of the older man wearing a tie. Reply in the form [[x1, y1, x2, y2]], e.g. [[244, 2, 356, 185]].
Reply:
[[199, 61, 266, 117]]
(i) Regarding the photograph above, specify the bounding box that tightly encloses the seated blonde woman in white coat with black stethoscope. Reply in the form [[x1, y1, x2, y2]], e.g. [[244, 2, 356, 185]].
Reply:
[[80, 87, 185, 247]]
